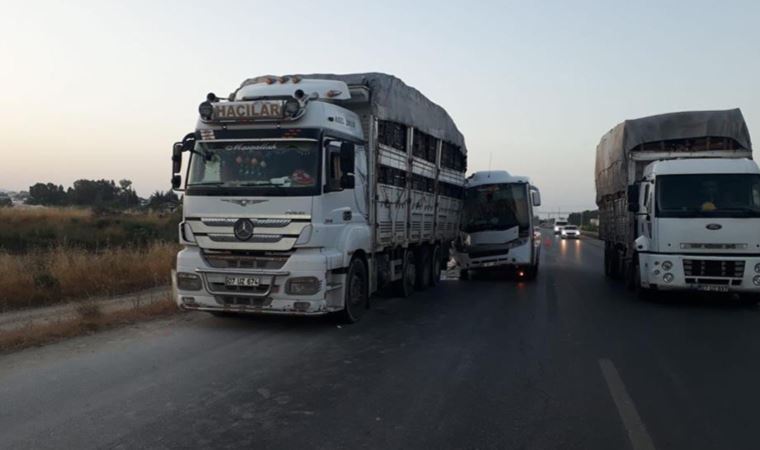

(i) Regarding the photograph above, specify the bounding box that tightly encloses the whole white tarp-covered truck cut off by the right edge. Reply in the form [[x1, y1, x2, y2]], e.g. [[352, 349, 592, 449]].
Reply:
[[596, 109, 760, 302]]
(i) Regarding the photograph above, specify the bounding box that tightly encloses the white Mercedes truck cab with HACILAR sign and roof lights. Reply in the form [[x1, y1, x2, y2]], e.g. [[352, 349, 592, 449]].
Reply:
[[174, 76, 370, 315]]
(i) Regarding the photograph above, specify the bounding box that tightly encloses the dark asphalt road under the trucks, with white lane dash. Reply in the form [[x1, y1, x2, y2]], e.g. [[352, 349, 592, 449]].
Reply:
[[0, 237, 760, 449]]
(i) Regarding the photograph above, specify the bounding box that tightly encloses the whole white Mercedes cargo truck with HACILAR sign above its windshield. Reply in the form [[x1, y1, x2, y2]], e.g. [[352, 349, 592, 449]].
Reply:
[[172, 73, 466, 322]]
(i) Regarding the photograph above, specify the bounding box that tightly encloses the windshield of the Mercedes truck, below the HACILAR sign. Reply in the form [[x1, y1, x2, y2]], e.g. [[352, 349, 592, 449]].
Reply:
[[187, 140, 319, 195]]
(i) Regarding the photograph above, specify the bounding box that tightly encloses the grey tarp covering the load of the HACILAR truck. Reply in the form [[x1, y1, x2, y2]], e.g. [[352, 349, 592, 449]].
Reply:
[[240, 72, 467, 154]]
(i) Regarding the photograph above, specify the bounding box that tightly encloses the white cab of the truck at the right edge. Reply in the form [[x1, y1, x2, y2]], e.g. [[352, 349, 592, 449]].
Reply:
[[629, 158, 760, 294]]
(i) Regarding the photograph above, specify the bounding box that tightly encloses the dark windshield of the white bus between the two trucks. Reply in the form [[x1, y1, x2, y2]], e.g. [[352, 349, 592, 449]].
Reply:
[[463, 184, 530, 233]]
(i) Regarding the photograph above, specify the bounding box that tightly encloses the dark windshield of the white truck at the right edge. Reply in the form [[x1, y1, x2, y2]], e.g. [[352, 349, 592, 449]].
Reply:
[[656, 174, 760, 217]]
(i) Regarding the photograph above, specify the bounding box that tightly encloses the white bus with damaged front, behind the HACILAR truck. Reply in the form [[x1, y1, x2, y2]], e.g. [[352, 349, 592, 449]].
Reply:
[[454, 170, 541, 280]]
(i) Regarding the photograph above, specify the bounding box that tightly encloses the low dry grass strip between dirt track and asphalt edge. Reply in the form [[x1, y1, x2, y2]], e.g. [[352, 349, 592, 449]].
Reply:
[[0, 296, 178, 352]]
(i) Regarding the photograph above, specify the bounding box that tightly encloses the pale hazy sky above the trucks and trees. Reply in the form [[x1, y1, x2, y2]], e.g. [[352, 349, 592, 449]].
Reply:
[[0, 0, 760, 210]]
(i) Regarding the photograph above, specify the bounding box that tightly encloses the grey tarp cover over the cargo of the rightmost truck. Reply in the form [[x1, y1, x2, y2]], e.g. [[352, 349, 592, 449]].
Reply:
[[595, 108, 752, 204]]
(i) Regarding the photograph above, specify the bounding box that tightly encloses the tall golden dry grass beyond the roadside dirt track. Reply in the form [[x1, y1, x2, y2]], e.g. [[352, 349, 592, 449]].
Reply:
[[0, 242, 179, 311]]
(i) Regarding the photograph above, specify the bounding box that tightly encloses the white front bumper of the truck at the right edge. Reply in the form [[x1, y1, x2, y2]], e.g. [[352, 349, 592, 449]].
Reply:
[[639, 253, 760, 293]]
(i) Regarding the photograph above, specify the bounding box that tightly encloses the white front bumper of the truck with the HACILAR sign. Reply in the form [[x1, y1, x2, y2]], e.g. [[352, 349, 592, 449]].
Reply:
[[173, 247, 345, 316]]
